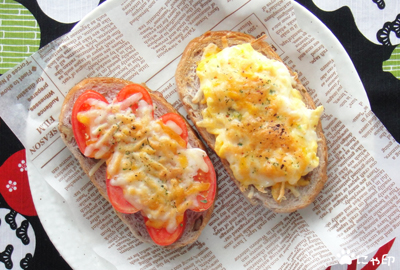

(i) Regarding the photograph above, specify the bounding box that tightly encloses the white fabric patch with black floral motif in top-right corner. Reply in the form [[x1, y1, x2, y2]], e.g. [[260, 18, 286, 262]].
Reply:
[[313, 0, 400, 46]]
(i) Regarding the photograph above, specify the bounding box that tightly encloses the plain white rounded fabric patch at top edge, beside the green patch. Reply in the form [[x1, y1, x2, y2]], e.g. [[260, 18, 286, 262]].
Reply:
[[37, 0, 100, 23]]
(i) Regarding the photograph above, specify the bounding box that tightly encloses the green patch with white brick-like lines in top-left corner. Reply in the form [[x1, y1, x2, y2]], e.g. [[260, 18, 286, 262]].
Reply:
[[0, 0, 40, 74]]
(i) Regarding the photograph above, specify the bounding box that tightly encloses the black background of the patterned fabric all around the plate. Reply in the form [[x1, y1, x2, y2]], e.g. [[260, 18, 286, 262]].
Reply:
[[0, 0, 400, 270]]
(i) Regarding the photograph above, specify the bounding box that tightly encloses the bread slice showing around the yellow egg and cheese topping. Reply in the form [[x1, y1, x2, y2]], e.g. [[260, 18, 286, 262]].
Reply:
[[175, 31, 328, 212]]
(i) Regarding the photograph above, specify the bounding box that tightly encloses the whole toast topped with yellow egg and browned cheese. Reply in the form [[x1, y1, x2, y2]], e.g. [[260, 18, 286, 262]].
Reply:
[[175, 31, 327, 212]]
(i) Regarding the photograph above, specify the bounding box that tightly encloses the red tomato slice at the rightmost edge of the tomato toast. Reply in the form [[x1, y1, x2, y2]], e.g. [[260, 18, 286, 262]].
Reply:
[[192, 156, 217, 212]]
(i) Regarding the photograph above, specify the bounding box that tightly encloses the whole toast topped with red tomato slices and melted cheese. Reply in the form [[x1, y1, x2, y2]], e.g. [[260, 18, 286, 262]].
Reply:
[[59, 78, 216, 248]]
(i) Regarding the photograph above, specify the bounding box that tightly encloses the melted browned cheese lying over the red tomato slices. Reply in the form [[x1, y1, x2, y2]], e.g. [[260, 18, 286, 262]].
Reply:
[[78, 94, 210, 232]]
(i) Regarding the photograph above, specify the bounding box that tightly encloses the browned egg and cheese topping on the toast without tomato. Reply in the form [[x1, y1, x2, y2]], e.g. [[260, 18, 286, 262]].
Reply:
[[193, 44, 323, 201]]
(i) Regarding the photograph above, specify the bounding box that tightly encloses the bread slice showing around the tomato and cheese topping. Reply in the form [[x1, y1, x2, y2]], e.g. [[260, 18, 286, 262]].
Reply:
[[58, 78, 214, 248]]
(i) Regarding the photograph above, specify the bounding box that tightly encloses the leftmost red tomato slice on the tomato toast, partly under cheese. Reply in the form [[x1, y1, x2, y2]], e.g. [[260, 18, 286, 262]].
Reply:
[[72, 90, 108, 157]]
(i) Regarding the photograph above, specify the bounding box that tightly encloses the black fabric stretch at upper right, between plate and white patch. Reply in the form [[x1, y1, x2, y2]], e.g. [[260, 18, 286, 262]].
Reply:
[[296, 0, 400, 142]]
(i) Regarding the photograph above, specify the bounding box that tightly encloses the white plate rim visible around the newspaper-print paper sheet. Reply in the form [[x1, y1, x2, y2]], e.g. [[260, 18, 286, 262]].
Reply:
[[27, 0, 369, 270]]
